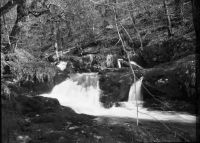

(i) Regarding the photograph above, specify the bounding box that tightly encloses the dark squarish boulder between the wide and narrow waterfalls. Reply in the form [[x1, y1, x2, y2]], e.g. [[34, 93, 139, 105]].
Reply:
[[99, 68, 142, 107]]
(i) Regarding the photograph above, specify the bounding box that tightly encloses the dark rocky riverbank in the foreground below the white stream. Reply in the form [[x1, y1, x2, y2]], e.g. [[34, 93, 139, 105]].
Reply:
[[2, 96, 196, 143]]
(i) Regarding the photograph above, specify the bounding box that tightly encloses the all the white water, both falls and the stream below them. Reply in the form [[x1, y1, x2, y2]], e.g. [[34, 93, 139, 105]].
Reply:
[[41, 73, 196, 122]]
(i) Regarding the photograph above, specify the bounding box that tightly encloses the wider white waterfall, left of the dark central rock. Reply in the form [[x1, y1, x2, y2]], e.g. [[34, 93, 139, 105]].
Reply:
[[42, 73, 101, 114]]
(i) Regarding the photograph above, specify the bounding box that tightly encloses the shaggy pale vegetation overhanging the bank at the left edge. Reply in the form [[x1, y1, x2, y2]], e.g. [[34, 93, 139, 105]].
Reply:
[[1, 49, 56, 95]]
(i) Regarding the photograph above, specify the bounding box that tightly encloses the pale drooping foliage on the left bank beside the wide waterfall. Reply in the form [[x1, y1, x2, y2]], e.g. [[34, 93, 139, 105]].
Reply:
[[1, 49, 56, 88]]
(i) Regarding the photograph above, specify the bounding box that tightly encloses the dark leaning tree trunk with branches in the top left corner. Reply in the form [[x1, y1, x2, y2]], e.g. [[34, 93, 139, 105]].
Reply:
[[0, 0, 49, 53]]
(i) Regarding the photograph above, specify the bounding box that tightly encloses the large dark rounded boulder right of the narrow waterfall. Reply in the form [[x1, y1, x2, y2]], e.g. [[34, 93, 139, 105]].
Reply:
[[142, 55, 197, 113]]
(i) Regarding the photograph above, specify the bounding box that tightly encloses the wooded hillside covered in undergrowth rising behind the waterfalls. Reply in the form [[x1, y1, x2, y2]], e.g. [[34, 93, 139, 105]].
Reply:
[[1, 0, 197, 95]]
